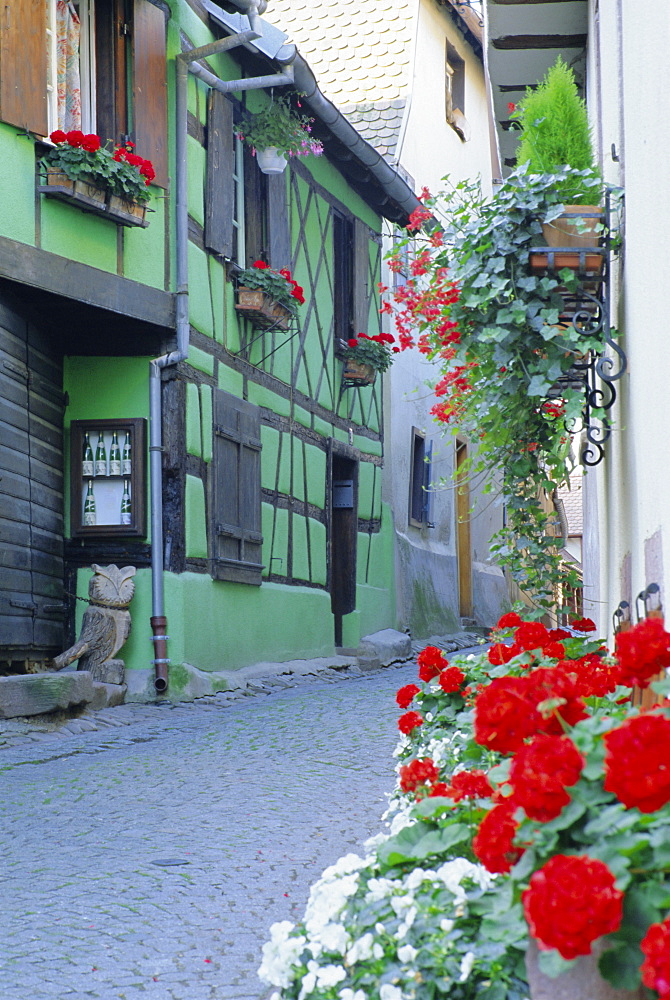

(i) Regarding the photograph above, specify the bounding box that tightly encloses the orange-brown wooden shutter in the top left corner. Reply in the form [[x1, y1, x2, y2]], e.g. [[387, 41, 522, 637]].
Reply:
[[0, 0, 49, 135]]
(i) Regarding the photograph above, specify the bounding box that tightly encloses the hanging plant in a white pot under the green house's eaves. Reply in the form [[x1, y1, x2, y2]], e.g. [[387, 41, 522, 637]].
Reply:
[[237, 96, 323, 174]]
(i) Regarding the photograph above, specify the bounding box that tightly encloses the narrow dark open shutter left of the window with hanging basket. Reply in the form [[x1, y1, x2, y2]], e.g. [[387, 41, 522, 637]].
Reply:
[[205, 90, 235, 257]]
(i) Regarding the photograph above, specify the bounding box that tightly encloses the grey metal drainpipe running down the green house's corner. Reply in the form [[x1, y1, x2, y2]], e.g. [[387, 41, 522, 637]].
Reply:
[[149, 9, 293, 694]]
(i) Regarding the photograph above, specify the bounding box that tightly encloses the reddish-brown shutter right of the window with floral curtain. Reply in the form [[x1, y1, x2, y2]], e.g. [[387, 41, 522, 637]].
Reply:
[[133, 0, 168, 187]]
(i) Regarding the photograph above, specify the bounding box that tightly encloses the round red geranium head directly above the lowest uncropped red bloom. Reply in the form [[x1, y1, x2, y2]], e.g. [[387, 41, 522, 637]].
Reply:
[[509, 733, 585, 823]]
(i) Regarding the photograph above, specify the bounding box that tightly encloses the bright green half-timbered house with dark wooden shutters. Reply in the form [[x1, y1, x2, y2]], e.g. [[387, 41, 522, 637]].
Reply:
[[0, 0, 417, 697]]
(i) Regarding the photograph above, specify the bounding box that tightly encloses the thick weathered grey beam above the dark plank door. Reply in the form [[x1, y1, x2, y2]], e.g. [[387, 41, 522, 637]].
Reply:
[[0, 236, 175, 328]]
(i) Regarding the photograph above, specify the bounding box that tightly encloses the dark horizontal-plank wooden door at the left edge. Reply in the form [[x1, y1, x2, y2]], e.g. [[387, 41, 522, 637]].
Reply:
[[0, 294, 65, 661]]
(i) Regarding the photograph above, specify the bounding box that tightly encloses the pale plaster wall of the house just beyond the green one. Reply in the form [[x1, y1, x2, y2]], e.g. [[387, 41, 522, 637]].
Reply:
[[385, 0, 506, 633]]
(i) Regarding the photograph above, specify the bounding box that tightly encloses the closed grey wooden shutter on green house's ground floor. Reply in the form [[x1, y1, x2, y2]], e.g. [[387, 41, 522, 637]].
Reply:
[[212, 390, 263, 586]]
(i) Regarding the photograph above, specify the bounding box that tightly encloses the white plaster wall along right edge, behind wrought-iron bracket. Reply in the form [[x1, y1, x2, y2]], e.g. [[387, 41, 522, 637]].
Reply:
[[585, 0, 670, 627]]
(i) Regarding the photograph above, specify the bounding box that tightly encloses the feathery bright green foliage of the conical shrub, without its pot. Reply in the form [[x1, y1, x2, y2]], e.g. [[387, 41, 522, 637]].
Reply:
[[511, 56, 599, 205]]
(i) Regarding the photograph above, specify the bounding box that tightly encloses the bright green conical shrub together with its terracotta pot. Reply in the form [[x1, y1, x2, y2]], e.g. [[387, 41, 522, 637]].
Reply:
[[510, 56, 602, 247]]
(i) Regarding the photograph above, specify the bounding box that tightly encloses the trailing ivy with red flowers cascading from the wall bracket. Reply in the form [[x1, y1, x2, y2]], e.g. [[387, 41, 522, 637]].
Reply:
[[382, 167, 606, 608]]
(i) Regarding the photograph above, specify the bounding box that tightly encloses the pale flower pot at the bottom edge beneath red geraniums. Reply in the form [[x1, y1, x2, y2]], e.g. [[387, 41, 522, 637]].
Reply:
[[526, 940, 645, 1000]]
